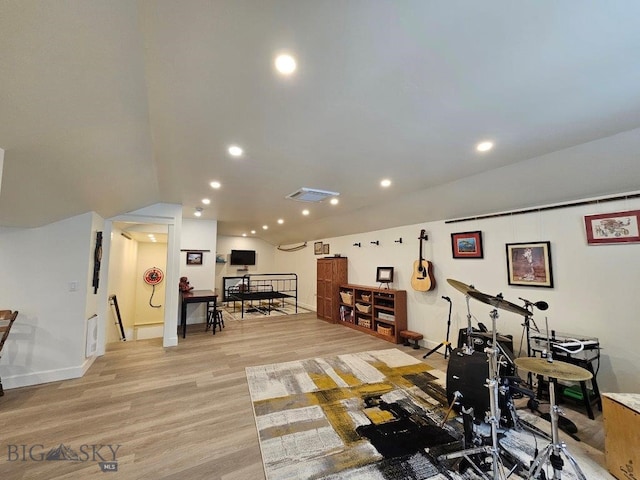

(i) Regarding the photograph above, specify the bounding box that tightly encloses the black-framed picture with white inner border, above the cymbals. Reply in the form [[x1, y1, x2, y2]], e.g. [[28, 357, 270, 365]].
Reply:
[[506, 242, 553, 288]]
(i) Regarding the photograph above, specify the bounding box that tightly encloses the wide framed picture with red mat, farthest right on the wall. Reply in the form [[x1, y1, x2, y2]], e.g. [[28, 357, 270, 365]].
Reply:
[[584, 210, 640, 245]]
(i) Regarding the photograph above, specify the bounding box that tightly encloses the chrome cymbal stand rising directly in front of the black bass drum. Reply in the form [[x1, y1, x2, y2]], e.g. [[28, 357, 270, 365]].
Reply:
[[438, 309, 506, 480]]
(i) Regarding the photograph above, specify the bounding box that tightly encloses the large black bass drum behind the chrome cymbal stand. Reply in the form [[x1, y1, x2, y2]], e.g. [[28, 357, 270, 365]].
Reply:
[[447, 348, 513, 427]]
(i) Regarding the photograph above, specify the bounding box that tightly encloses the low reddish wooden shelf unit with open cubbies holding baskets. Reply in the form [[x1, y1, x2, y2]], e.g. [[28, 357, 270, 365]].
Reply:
[[338, 283, 407, 343]]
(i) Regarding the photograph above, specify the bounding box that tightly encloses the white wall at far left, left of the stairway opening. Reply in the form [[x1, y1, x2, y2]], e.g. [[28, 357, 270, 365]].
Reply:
[[0, 213, 103, 388]]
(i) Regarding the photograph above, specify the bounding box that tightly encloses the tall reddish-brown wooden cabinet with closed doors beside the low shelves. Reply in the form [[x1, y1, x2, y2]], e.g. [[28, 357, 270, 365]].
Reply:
[[316, 257, 348, 323]]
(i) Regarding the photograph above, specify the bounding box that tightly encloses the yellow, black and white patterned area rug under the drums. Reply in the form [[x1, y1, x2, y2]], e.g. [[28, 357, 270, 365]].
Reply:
[[246, 348, 613, 480]]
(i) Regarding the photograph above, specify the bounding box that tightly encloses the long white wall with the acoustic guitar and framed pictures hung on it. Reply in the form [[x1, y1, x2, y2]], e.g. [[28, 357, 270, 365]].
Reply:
[[275, 195, 640, 392]]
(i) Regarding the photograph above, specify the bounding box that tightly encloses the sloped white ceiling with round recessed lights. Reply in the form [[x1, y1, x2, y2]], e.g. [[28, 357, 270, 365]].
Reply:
[[0, 0, 640, 245]]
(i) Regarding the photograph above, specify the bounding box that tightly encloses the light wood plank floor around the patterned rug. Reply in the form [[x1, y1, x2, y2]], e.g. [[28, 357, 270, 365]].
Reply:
[[0, 313, 602, 480]]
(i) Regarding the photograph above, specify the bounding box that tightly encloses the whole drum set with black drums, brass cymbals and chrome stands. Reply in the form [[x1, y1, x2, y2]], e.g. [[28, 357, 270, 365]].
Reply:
[[438, 279, 592, 480]]
